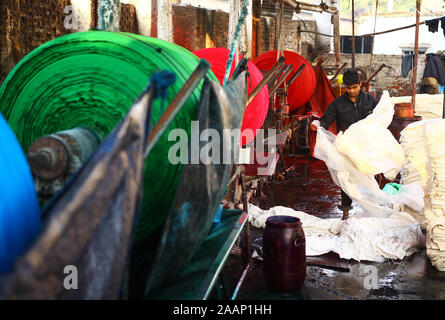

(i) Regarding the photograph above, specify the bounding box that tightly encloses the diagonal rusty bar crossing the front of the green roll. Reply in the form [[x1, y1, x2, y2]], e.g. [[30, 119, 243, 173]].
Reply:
[[145, 59, 210, 156]]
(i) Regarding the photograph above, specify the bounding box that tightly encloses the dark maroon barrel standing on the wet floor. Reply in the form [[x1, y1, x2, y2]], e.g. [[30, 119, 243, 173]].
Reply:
[[263, 216, 306, 292]]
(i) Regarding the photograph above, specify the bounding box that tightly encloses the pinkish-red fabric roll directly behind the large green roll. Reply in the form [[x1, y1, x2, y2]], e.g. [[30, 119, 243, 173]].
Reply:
[[194, 48, 269, 145]]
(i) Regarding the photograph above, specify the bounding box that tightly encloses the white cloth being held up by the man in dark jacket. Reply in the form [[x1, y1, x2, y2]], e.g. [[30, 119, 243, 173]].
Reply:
[[314, 91, 424, 218]]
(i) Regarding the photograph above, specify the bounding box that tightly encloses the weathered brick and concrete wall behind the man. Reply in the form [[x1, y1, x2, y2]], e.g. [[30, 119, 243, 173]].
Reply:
[[318, 54, 426, 97]]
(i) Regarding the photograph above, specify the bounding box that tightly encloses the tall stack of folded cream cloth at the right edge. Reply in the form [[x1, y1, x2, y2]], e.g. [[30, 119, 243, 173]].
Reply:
[[401, 119, 445, 271]]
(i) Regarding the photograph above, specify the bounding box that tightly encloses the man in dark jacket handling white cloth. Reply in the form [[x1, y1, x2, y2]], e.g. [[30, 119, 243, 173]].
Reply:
[[311, 70, 377, 219]]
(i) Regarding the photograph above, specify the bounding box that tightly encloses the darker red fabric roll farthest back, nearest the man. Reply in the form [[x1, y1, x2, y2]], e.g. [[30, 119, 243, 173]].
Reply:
[[253, 50, 316, 113]]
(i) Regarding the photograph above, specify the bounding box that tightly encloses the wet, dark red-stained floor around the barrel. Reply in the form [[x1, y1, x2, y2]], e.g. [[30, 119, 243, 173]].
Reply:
[[223, 155, 445, 300]]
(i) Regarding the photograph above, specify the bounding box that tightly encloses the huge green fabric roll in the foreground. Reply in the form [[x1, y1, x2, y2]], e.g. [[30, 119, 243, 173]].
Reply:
[[0, 31, 217, 242]]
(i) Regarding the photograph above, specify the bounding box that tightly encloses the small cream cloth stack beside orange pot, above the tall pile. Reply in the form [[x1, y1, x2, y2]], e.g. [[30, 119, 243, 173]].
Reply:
[[391, 93, 443, 119]]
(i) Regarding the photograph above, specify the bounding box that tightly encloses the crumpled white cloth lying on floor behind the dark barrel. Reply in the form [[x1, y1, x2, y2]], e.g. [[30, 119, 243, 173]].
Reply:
[[248, 204, 425, 262]]
